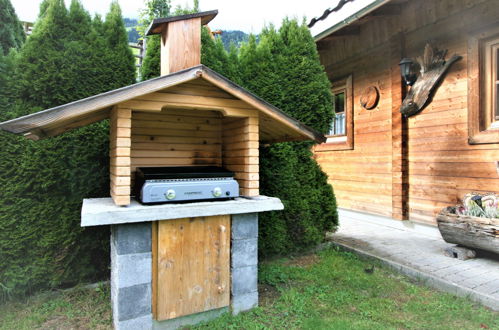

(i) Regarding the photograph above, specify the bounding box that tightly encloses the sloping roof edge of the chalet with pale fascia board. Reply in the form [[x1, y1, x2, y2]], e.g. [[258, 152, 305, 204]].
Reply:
[[314, 0, 399, 43]]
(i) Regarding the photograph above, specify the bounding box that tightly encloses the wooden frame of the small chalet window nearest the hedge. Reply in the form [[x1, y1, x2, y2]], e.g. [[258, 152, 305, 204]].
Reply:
[[314, 74, 354, 151]]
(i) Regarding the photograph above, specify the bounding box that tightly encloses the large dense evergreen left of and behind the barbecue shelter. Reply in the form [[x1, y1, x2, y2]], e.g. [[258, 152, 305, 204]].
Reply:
[[0, 0, 135, 294]]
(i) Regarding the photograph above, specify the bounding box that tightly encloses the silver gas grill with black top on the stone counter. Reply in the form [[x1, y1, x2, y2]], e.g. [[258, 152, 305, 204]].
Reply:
[[135, 166, 239, 204]]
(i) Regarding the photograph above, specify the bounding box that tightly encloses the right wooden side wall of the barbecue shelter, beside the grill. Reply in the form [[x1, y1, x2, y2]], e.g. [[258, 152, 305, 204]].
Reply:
[[223, 117, 260, 196]]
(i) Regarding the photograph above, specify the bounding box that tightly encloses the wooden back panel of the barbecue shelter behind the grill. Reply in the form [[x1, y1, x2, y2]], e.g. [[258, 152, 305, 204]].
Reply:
[[131, 109, 222, 171]]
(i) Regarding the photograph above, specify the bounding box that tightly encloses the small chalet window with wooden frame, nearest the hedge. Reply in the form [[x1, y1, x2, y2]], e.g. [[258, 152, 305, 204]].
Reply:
[[315, 75, 353, 151]]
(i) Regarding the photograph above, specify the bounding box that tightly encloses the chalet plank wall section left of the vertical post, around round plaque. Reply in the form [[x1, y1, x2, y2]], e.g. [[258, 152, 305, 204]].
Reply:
[[315, 47, 392, 216]]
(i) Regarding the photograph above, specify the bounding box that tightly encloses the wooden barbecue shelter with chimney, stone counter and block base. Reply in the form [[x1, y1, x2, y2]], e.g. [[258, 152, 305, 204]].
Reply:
[[0, 10, 325, 329]]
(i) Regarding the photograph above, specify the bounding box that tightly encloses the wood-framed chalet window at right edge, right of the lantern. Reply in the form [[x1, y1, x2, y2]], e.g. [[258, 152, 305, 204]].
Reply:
[[468, 27, 499, 144]]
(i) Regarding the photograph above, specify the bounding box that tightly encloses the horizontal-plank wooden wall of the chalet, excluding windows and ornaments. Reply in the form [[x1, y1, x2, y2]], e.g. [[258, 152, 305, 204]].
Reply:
[[316, 0, 499, 225]]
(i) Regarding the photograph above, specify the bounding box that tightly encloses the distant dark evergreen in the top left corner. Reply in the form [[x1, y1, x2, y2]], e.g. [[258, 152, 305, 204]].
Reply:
[[0, 0, 26, 55]]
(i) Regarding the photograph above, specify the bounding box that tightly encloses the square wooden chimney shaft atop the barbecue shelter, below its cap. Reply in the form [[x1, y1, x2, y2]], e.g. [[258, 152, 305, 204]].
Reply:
[[161, 17, 201, 76]]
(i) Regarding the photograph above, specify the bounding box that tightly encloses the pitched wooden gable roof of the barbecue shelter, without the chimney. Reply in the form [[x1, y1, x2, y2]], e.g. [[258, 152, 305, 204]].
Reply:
[[0, 65, 326, 143]]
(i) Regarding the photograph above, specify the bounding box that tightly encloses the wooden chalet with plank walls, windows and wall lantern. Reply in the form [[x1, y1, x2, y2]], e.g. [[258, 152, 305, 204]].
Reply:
[[315, 0, 499, 225]]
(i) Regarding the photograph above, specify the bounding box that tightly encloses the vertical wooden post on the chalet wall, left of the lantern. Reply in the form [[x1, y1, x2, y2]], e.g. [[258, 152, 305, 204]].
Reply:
[[390, 33, 409, 220]]
